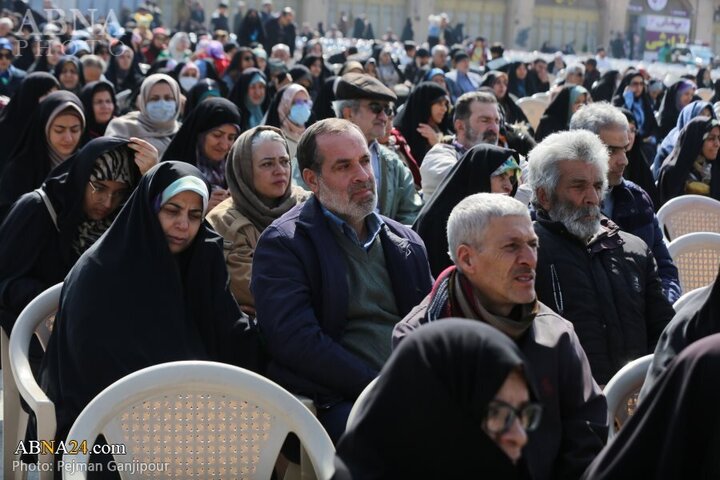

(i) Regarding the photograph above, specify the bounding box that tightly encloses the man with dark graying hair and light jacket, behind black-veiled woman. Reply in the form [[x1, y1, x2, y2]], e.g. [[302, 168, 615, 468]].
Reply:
[[420, 92, 500, 203]]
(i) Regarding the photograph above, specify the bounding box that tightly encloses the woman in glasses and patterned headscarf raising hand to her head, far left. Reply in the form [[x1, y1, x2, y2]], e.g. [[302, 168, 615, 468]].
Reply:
[[0, 137, 157, 333]]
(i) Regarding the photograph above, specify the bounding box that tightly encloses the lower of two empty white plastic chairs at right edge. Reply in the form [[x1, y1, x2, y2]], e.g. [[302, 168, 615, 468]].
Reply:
[[668, 232, 720, 292]]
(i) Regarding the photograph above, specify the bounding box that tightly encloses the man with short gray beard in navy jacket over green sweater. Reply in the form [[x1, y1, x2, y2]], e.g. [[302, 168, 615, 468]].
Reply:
[[250, 118, 432, 440]]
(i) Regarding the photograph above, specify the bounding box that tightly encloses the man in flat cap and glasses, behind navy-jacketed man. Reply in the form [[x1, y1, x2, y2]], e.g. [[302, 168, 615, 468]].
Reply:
[[333, 73, 422, 225]]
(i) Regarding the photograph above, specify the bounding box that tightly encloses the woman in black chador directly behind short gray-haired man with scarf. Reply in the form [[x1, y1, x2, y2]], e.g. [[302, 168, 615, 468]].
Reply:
[[413, 144, 520, 276]]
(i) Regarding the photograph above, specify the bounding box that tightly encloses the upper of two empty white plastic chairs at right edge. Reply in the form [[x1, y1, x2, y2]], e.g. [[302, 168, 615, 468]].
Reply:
[[658, 195, 720, 241]]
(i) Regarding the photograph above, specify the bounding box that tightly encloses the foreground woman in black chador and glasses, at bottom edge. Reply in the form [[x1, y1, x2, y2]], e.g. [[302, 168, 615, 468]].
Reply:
[[333, 319, 542, 480]]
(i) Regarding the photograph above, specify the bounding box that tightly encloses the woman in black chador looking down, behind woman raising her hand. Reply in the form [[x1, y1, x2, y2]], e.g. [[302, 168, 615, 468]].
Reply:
[[0, 90, 85, 220]]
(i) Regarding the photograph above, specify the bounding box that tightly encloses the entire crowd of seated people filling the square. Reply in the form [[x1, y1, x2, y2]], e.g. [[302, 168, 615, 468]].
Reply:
[[0, 1, 720, 479]]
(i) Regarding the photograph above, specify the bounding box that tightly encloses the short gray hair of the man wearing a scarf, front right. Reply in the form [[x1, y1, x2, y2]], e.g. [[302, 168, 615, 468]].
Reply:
[[447, 193, 530, 264]]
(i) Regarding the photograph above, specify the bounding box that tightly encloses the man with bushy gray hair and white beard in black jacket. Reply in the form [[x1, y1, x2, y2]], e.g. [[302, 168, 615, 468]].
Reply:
[[528, 130, 674, 385]]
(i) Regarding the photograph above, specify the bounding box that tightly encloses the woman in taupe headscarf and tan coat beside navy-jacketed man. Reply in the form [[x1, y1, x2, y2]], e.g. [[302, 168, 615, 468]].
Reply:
[[207, 125, 309, 315]]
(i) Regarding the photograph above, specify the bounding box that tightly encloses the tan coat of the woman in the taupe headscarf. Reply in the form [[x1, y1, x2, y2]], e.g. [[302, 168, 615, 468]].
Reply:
[[207, 198, 262, 307]]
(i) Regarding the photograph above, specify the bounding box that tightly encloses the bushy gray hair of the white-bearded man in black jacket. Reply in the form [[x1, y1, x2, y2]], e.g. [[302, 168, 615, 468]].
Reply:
[[527, 130, 610, 206]]
